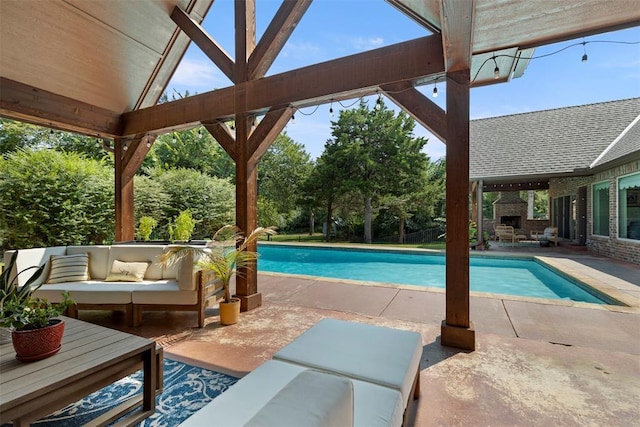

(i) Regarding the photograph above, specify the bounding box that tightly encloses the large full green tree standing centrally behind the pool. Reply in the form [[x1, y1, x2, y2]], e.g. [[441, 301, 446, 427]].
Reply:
[[323, 98, 428, 243]]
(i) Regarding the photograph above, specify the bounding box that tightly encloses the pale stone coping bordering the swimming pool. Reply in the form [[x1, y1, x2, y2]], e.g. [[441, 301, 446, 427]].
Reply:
[[258, 242, 640, 314]]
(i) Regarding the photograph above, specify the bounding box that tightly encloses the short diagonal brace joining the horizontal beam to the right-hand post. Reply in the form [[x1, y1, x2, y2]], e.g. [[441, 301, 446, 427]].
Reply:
[[380, 82, 447, 141]]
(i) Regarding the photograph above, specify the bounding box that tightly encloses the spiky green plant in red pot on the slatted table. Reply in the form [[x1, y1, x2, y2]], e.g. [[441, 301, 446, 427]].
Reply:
[[0, 252, 73, 362]]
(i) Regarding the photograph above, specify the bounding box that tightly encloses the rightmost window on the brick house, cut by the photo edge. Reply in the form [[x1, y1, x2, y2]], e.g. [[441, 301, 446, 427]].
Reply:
[[618, 173, 640, 240]]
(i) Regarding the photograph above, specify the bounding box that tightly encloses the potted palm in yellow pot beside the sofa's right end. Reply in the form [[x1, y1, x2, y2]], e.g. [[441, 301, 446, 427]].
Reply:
[[161, 225, 276, 325]]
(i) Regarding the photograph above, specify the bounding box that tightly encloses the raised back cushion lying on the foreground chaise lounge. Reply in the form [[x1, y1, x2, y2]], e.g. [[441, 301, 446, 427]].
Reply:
[[245, 370, 353, 427]]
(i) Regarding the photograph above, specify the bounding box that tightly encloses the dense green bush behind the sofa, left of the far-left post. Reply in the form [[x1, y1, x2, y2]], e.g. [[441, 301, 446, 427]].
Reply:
[[0, 150, 114, 248]]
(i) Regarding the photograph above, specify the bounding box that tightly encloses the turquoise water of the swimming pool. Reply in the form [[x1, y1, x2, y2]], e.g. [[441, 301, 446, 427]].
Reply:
[[258, 245, 608, 304]]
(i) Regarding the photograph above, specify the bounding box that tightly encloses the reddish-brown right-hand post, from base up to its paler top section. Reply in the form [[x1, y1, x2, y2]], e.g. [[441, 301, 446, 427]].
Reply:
[[441, 68, 475, 350]]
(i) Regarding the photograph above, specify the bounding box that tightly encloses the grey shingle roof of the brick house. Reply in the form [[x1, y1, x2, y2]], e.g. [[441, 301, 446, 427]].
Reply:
[[469, 98, 640, 180]]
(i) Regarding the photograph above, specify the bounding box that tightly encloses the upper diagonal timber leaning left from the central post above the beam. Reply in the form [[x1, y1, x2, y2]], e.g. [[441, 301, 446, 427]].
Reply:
[[171, 6, 235, 82]]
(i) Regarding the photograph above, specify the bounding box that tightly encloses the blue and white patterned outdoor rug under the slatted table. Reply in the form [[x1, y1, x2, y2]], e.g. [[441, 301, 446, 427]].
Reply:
[[35, 359, 238, 427]]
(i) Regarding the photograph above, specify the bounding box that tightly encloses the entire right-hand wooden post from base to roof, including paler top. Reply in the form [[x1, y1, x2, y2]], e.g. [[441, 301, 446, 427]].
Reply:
[[440, 0, 476, 350]]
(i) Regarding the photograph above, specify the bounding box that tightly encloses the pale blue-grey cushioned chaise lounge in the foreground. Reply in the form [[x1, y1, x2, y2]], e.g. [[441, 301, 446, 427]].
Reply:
[[181, 318, 422, 427]]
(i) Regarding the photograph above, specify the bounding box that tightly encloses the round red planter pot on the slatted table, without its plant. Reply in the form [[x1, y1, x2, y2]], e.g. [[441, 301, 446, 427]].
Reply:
[[11, 319, 64, 362]]
